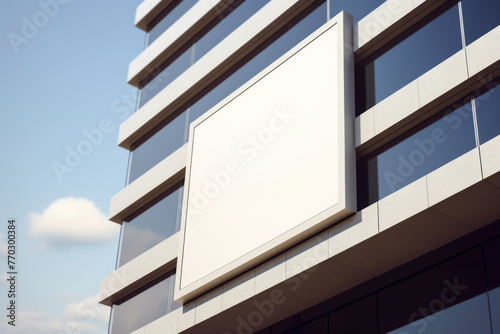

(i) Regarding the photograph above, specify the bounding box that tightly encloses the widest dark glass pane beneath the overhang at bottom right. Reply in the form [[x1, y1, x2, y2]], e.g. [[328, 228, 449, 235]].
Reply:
[[378, 248, 491, 334]]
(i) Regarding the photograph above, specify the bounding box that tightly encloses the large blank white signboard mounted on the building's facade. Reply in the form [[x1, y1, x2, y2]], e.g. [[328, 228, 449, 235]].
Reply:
[[177, 15, 355, 300]]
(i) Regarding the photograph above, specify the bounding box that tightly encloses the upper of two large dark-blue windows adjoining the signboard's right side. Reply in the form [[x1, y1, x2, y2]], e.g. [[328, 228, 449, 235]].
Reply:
[[356, 2, 462, 115]]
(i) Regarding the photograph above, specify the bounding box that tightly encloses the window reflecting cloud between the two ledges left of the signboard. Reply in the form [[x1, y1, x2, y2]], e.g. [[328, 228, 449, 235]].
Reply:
[[118, 186, 183, 266]]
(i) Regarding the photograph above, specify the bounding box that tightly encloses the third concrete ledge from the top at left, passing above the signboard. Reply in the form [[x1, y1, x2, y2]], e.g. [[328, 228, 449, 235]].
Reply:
[[118, 0, 313, 149]]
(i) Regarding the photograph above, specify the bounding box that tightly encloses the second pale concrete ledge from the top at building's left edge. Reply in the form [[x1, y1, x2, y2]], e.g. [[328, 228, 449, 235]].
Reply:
[[127, 0, 234, 87]]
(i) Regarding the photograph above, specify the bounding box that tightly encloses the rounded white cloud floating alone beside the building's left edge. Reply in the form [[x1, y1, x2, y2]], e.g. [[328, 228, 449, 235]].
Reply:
[[28, 197, 119, 248]]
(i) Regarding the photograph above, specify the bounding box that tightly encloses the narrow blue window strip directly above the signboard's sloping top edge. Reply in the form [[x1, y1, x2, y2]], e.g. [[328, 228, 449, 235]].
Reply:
[[189, 2, 326, 130]]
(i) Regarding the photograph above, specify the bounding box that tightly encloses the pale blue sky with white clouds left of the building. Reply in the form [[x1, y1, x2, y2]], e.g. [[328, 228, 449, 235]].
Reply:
[[0, 0, 145, 334]]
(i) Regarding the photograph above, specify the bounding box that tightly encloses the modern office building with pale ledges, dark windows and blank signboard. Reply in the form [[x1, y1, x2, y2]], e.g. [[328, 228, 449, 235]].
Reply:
[[100, 0, 500, 334]]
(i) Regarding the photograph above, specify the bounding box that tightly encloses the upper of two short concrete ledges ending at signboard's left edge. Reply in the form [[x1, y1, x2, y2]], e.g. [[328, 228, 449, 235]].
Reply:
[[109, 145, 187, 223]]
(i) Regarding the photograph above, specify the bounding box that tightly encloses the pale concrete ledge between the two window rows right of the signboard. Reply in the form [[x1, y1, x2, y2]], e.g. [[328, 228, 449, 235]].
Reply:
[[354, 27, 500, 158]]
